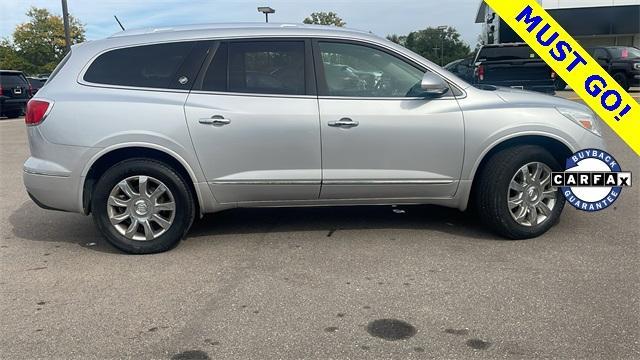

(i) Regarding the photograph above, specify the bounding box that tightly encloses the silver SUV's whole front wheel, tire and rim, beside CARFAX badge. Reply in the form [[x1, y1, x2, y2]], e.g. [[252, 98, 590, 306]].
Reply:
[[474, 145, 565, 240]]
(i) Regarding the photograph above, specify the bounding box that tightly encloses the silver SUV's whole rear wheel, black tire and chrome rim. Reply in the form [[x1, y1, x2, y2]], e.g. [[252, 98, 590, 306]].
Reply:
[[91, 159, 195, 254]]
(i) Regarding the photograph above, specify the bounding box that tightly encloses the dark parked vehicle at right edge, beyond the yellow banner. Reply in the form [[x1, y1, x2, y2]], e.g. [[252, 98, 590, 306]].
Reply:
[[587, 46, 640, 91]]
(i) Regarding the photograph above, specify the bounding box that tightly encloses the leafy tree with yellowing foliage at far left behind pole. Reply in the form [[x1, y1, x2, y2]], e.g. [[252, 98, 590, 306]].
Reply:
[[0, 7, 85, 74]]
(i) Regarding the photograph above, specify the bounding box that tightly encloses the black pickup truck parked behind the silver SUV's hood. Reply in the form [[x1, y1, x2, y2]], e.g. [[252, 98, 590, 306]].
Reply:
[[445, 43, 556, 94]]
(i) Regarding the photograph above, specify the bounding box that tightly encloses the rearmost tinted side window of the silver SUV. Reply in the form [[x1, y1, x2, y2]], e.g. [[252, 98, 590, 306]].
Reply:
[[84, 42, 195, 88]]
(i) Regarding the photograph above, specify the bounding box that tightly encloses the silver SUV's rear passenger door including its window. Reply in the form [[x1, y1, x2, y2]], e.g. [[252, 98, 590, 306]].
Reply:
[[185, 39, 321, 203]]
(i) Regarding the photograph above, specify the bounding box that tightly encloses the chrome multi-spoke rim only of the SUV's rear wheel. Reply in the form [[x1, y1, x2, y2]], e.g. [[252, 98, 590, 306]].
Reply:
[[107, 175, 176, 241]]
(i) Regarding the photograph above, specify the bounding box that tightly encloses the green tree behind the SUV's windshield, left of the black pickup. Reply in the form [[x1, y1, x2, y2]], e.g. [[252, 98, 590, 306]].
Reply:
[[387, 27, 471, 65]]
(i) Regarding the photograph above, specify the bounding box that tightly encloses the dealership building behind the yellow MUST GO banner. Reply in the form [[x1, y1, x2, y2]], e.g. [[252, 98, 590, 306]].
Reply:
[[476, 0, 640, 48]]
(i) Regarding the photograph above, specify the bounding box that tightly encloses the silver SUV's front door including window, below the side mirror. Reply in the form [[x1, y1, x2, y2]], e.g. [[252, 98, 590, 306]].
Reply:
[[314, 40, 464, 199]]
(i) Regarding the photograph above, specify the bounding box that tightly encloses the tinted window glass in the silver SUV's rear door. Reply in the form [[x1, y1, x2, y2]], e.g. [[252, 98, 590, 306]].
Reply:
[[226, 41, 305, 95]]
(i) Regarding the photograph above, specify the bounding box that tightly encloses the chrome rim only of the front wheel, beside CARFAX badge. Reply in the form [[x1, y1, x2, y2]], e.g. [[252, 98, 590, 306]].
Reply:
[[507, 162, 558, 226]]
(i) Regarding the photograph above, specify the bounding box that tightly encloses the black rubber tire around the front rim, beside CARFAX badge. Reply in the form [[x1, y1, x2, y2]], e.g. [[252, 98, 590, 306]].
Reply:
[[473, 145, 565, 240]]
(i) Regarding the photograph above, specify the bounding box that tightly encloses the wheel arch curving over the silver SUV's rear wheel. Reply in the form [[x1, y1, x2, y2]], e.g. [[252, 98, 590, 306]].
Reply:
[[80, 144, 203, 215]]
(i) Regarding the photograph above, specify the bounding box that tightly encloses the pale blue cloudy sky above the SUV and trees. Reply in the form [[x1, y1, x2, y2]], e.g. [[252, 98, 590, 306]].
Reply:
[[0, 0, 481, 47]]
